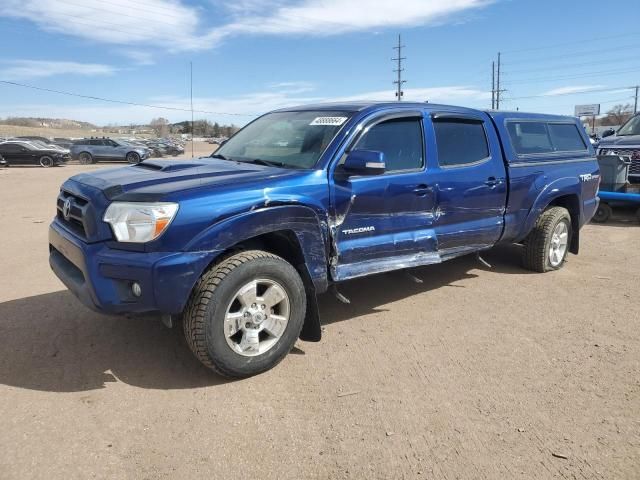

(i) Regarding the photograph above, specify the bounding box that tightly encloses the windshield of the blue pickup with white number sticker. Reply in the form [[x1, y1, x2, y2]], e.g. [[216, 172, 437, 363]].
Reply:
[[212, 111, 351, 168]]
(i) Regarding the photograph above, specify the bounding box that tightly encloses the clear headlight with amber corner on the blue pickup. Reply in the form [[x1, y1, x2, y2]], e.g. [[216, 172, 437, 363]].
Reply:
[[103, 202, 178, 243]]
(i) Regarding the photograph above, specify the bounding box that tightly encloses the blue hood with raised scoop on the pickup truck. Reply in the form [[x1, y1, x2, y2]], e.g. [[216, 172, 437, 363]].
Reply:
[[70, 157, 308, 201]]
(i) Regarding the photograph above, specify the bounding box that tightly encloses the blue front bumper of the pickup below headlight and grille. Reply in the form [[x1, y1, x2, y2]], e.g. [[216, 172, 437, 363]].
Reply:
[[49, 221, 219, 314]]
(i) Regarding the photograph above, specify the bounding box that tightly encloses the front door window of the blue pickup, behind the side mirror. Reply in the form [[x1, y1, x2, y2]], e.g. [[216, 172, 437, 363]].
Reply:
[[354, 118, 424, 172]]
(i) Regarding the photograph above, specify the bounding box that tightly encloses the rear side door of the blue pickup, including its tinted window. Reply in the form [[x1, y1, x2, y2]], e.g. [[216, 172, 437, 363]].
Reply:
[[427, 112, 507, 258]]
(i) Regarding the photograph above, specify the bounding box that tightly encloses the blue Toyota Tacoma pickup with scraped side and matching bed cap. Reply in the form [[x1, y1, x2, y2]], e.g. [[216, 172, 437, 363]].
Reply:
[[49, 102, 599, 377]]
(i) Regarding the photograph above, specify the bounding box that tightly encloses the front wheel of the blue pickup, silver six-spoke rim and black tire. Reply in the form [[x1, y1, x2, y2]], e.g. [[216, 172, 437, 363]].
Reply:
[[183, 250, 306, 378]]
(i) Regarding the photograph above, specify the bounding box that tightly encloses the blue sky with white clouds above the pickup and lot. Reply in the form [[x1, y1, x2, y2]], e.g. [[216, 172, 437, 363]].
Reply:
[[0, 0, 640, 125]]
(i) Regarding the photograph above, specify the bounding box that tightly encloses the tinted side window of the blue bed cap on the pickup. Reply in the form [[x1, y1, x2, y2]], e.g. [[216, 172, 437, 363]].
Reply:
[[507, 120, 587, 156]]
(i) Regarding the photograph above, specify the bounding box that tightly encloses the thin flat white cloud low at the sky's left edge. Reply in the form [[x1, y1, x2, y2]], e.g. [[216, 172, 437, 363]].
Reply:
[[2, 60, 117, 80]]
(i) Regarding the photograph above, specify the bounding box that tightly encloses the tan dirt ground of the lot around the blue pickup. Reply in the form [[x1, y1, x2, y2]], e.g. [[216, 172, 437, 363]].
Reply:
[[0, 159, 640, 480]]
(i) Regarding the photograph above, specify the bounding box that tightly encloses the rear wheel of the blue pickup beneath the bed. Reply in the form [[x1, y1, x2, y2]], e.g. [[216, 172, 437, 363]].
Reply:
[[522, 207, 572, 273]]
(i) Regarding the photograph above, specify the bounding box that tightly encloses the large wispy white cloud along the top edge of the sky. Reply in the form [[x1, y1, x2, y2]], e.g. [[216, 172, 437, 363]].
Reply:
[[0, 0, 495, 52]]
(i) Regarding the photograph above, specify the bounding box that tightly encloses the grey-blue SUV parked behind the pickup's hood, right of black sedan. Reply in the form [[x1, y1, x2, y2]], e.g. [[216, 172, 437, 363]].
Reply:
[[71, 138, 149, 165]]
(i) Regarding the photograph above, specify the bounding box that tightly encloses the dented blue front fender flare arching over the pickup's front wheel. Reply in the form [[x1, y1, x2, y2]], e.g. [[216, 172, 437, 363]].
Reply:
[[185, 205, 328, 293]]
